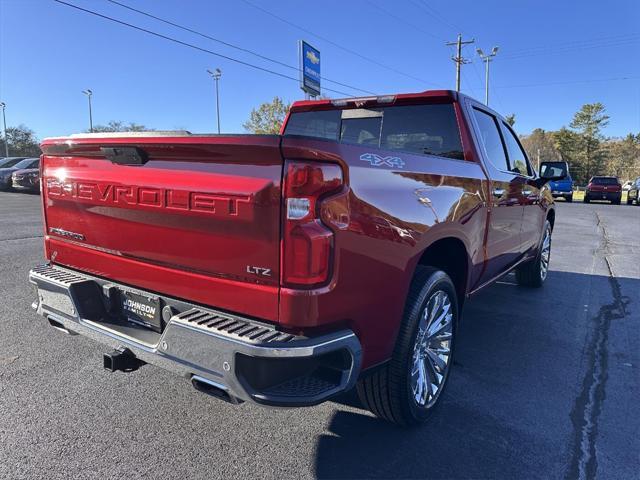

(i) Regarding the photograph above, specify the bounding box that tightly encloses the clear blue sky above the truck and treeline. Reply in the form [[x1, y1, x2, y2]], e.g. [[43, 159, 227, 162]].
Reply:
[[0, 0, 640, 138]]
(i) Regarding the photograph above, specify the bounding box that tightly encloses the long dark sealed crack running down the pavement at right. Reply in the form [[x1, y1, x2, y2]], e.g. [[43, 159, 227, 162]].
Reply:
[[565, 213, 629, 480]]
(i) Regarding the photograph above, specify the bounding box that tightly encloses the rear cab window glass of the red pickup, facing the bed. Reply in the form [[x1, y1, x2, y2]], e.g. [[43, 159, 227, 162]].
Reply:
[[284, 103, 464, 160]]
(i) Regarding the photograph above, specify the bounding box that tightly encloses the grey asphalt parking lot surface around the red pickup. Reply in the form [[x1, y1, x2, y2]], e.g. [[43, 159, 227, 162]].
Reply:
[[0, 193, 640, 479]]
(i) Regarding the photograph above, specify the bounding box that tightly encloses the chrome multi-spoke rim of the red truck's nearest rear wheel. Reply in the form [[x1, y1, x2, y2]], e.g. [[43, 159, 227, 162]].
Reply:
[[410, 290, 453, 408]]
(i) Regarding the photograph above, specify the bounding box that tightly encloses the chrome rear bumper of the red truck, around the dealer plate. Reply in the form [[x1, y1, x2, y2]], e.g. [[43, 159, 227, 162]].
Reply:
[[29, 265, 361, 406]]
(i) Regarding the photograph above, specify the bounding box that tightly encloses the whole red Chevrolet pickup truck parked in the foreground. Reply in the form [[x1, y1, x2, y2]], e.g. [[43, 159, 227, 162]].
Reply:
[[30, 91, 564, 424]]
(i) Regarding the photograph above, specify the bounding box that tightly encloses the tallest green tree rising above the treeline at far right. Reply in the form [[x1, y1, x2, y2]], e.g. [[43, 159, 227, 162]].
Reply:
[[569, 103, 609, 180]]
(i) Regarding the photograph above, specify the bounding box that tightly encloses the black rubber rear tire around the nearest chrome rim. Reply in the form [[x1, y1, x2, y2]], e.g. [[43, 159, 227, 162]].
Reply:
[[357, 266, 459, 426]]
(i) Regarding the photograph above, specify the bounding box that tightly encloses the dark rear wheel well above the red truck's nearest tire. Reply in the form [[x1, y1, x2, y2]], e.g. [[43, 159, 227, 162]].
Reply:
[[418, 237, 469, 306]]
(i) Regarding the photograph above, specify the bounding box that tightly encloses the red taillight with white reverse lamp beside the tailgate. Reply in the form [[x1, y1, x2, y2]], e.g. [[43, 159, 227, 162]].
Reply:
[[282, 161, 343, 287]]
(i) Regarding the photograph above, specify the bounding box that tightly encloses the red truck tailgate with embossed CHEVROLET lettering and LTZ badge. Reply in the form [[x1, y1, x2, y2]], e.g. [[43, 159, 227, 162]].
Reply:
[[42, 135, 283, 320]]
